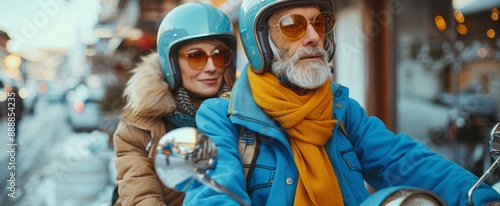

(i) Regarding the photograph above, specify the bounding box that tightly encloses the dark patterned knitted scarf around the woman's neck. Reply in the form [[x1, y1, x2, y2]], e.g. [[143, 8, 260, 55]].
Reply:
[[166, 84, 230, 127]]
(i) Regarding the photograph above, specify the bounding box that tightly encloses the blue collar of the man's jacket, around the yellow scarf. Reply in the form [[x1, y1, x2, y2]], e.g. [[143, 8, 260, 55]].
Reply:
[[228, 67, 349, 137]]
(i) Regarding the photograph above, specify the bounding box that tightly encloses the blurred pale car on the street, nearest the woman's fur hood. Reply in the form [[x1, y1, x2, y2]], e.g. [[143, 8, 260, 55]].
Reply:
[[66, 84, 102, 131]]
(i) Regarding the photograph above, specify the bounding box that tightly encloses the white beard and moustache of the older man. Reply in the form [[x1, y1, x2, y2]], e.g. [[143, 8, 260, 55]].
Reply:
[[272, 47, 331, 89]]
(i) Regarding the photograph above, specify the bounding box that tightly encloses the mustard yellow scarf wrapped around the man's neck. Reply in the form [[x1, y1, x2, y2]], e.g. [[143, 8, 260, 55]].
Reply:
[[247, 68, 344, 206]]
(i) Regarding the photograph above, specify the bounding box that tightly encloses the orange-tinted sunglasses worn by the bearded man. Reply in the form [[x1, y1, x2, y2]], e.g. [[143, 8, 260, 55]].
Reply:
[[269, 12, 335, 41]]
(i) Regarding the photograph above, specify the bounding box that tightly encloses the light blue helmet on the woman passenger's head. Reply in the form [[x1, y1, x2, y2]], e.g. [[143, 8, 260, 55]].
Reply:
[[157, 3, 236, 90]]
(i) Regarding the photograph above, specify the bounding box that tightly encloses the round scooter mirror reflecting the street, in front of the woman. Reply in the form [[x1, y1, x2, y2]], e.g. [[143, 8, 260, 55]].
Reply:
[[155, 127, 217, 192]]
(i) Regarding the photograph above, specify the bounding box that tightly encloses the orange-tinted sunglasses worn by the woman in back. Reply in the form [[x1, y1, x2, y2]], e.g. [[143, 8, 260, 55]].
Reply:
[[179, 48, 232, 70]]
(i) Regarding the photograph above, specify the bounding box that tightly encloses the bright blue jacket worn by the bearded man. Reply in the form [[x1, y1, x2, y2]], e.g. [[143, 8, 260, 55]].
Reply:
[[184, 67, 500, 206]]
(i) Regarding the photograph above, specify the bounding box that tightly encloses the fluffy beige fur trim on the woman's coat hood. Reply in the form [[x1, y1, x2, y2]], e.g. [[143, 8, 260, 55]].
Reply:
[[122, 52, 176, 120]]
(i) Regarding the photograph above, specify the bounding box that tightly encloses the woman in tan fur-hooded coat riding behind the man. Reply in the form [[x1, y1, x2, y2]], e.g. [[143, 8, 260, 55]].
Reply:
[[113, 3, 236, 206]]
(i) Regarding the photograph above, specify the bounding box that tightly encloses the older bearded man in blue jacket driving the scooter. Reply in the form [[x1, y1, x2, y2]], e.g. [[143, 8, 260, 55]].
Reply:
[[184, 0, 500, 206]]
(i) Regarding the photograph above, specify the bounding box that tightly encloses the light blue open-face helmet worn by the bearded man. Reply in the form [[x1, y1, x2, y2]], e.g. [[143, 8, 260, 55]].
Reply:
[[238, 0, 335, 73]]
